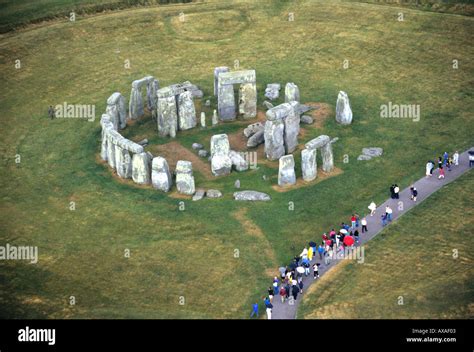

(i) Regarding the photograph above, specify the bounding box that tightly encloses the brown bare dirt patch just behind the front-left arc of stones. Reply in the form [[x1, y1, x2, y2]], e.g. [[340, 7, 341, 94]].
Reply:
[[149, 141, 214, 180]]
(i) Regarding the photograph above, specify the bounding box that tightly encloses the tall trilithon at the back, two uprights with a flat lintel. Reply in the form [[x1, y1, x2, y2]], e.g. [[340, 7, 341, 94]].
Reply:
[[218, 70, 257, 121]]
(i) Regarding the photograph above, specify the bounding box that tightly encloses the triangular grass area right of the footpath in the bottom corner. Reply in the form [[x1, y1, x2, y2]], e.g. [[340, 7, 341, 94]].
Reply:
[[298, 172, 474, 319]]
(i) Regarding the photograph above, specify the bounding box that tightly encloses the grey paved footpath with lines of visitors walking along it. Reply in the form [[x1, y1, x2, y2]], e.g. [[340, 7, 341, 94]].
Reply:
[[272, 148, 472, 319]]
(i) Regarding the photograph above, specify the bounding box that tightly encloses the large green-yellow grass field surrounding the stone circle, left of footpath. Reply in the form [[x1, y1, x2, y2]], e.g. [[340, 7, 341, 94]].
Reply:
[[0, 1, 474, 318]]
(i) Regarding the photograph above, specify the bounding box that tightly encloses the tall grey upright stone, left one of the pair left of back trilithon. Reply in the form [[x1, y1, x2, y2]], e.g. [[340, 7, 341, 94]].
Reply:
[[157, 87, 178, 137]]
